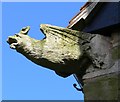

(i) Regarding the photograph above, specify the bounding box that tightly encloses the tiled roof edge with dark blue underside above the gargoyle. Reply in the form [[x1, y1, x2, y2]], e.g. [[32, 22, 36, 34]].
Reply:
[[67, 2, 120, 33]]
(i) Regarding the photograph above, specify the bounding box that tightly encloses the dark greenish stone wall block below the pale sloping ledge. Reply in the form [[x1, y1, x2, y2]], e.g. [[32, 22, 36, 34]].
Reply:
[[83, 72, 120, 102]]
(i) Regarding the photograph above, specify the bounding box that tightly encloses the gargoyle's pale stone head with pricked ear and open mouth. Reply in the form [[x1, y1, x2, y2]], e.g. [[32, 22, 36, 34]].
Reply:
[[7, 26, 30, 50]]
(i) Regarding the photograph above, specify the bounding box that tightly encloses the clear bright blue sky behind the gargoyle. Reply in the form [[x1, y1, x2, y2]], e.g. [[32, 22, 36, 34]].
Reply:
[[2, 2, 84, 100]]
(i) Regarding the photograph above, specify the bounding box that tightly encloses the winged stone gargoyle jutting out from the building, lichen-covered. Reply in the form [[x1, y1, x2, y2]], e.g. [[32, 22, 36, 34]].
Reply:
[[7, 24, 109, 77]]
